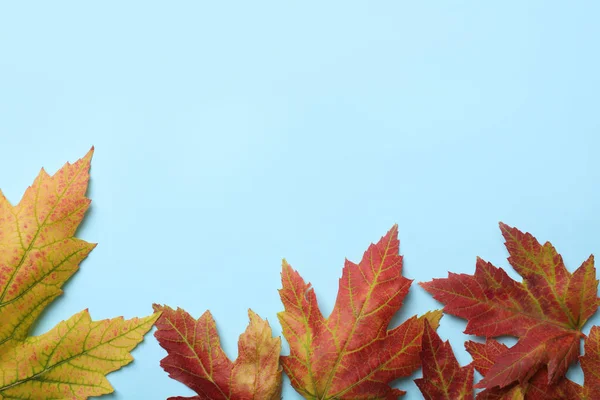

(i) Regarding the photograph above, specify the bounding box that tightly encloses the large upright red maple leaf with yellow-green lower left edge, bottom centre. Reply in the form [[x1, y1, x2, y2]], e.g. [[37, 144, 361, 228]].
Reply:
[[278, 226, 441, 400]]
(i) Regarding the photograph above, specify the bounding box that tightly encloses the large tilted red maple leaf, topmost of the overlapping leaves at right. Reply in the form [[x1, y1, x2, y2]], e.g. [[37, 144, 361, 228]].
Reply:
[[421, 223, 600, 389]]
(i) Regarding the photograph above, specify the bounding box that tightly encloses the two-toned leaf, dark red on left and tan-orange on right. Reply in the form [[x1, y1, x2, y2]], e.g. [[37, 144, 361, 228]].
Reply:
[[154, 304, 282, 400]]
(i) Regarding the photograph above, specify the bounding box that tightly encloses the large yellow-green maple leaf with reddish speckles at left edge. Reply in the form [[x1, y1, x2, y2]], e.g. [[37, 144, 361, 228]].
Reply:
[[0, 148, 158, 400]]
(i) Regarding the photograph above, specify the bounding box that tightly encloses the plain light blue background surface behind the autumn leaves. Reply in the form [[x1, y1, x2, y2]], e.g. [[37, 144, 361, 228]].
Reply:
[[0, 1, 600, 400]]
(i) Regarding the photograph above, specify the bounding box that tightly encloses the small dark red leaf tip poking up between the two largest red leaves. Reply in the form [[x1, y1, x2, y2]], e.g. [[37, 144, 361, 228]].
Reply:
[[415, 321, 473, 400]]
